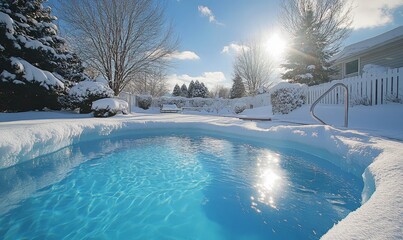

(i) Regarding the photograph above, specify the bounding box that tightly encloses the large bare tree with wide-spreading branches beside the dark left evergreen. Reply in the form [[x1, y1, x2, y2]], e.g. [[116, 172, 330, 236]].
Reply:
[[60, 0, 177, 95]]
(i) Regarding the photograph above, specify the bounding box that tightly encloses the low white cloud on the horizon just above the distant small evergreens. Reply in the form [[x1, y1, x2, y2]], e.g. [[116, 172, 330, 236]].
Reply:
[[168, 72, 229, 90]]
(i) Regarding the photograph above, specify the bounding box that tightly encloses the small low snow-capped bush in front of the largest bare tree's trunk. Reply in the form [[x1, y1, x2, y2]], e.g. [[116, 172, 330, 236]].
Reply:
[[91, 98, 129, 117]]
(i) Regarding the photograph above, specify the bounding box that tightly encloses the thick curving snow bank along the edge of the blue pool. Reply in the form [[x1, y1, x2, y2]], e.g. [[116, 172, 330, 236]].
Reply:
[[0, 114, 403, 239]]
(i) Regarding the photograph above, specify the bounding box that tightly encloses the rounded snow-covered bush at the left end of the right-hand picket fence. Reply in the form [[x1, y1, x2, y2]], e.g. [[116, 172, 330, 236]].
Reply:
[[271, 84, 306, 114]]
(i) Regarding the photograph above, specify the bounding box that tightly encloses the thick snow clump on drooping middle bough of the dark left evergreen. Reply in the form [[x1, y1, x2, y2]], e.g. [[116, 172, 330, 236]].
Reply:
[[10, 57, 64, 89]]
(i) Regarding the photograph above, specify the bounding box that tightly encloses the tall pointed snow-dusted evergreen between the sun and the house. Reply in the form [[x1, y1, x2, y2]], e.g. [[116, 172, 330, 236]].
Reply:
[[282, 1, 334, 85]]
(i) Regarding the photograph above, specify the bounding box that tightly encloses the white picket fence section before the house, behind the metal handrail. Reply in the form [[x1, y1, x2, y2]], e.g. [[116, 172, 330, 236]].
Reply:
[[306, 68, 403, 105]]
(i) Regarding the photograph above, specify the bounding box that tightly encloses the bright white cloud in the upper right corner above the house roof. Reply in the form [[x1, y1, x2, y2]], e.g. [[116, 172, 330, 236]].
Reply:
[[352, 0, 403, 29]]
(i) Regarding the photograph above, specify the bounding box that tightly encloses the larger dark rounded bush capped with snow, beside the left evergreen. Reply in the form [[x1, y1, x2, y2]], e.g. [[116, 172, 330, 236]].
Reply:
[[66, 80, 114, 113]]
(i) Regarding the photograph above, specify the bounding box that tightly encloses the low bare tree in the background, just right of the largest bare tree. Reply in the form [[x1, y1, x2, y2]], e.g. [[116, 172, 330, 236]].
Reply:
[[125, 69, 169, 97]]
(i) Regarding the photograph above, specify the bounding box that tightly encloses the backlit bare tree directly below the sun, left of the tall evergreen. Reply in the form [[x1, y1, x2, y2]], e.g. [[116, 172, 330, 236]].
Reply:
[[234, 41, 274, 95]]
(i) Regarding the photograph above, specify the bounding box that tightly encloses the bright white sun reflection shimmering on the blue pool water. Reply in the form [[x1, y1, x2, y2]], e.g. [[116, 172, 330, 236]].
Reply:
[[251, 151, 286, 213]]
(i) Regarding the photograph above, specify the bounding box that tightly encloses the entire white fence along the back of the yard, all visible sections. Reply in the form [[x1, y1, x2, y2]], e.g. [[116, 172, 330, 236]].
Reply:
[[119, 67, 403, 110]]
